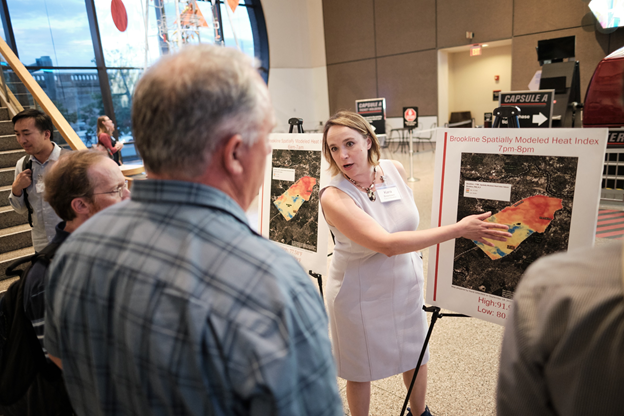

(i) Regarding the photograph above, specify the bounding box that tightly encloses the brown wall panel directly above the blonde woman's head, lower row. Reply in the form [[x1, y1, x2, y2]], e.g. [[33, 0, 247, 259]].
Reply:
[[327, 59, 377, 114]]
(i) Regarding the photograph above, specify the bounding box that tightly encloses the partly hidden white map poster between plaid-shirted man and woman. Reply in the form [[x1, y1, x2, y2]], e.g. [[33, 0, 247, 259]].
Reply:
[[258, 133, 330, 282]]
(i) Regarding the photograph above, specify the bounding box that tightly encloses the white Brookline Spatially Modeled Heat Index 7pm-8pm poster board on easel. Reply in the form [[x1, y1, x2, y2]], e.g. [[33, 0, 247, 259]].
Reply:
[[426, 129, 607, 325]]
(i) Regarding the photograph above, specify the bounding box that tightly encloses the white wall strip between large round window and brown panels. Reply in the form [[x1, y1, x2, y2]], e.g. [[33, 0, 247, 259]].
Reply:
[[262, 0, 329, 133]]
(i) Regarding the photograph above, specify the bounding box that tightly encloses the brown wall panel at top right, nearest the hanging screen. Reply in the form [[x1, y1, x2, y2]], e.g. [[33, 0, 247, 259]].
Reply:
[[514, 0, 595, 36]]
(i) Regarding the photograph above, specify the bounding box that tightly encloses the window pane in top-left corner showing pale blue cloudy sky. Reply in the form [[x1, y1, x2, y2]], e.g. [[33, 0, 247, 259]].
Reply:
[[7, 0, 95, 67]]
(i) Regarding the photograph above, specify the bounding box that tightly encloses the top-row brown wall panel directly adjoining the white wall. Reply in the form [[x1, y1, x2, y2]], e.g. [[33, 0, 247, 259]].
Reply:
[[323, 0, 375, 65]]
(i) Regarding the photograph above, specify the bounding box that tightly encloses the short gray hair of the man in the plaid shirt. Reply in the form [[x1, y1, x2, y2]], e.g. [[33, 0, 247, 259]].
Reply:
[[132, 45, 272, 178]]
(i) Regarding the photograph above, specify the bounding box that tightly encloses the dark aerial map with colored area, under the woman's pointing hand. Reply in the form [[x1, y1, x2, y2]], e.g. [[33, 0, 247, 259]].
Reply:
[[453, 153, 578, 298]]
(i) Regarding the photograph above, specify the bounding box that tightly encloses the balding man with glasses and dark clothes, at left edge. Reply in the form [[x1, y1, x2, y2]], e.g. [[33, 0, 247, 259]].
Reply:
[[0, 150, 130, 416]]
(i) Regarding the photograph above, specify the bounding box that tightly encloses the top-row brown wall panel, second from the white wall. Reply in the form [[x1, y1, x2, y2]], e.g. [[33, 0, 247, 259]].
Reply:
[[375, 0, 436, 56]]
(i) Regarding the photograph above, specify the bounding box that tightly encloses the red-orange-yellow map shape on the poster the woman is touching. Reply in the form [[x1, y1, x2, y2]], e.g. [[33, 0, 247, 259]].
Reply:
[[474, 195, 563, 260]]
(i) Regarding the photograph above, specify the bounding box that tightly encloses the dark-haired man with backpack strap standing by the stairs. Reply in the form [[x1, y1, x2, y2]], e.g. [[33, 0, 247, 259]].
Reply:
[[9, 109, 61, 251]]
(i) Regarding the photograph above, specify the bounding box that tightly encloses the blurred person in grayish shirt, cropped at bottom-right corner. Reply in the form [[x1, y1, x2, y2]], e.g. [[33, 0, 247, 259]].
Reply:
[[497, 241, 624, 416]]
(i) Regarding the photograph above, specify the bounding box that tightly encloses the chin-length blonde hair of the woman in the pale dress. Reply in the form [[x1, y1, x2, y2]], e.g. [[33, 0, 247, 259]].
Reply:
[[323, 111, 381, 176]]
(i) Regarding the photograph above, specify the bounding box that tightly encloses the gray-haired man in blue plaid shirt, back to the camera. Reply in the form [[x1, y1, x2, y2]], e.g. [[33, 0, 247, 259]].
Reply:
[[45, 45, 342, 415]]
